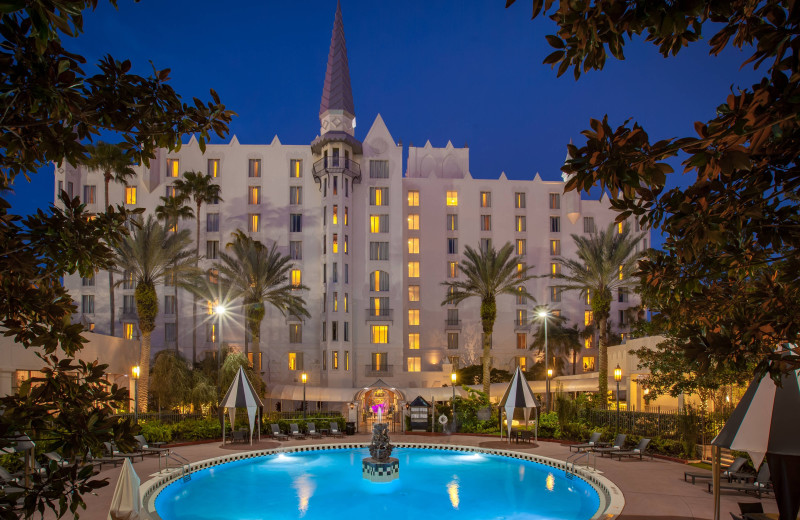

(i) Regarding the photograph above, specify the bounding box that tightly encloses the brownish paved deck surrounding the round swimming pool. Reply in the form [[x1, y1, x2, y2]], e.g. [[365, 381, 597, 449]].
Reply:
[[64, 434, 777, 520]]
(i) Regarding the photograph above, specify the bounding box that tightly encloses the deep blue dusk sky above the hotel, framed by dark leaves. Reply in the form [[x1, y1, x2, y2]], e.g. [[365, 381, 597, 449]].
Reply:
[[8, 0, 759, 245]]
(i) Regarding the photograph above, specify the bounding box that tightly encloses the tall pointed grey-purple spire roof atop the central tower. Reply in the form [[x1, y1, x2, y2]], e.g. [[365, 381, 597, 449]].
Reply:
[[319, 1, 356, 116]]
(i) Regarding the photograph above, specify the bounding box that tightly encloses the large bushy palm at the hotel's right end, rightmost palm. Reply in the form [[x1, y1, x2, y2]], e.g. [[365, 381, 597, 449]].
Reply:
[[553, 222, 644, 399]]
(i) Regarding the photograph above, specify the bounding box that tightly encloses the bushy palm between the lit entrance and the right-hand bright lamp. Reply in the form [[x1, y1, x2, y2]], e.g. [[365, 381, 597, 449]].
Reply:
[[442, 242, 535, 397]]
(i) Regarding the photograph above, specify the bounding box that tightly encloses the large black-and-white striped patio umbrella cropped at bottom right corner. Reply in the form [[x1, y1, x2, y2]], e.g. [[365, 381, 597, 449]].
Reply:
[[711, 370, 800, 520]]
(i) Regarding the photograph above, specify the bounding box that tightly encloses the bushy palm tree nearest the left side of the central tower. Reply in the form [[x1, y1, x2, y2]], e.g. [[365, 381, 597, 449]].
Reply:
[[216, 230, 310, 375]]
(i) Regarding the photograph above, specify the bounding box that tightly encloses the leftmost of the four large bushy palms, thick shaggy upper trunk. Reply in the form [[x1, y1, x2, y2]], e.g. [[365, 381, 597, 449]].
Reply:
[[114, 215, 196, 411]]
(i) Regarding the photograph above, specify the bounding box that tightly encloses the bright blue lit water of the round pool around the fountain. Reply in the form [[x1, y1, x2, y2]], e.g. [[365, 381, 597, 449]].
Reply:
[[155, 448, 600, 520]]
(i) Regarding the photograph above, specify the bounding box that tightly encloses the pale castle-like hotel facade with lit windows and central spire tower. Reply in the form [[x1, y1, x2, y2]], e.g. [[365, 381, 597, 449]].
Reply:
[[55, 4, 647, 396]]
